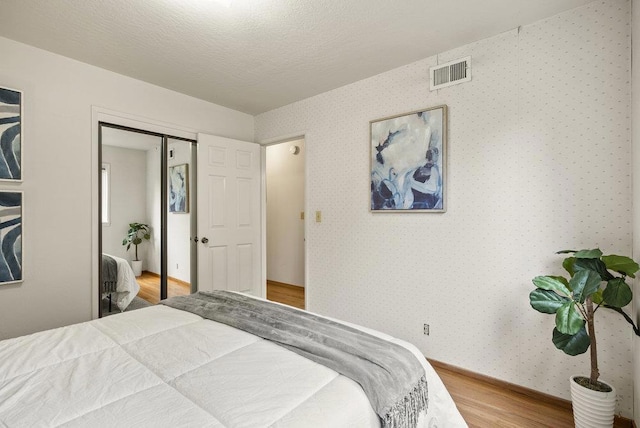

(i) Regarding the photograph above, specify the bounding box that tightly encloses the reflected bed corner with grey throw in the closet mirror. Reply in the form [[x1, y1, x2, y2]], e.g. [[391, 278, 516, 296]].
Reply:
[[102, 253, 140, 312]]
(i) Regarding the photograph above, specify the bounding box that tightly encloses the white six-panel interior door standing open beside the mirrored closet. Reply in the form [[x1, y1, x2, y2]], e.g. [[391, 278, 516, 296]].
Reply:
[[197, 134, 264, 297]]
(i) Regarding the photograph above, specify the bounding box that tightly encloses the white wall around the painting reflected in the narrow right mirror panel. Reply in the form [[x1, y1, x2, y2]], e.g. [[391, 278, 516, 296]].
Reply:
[[167, 140, 193, 282]]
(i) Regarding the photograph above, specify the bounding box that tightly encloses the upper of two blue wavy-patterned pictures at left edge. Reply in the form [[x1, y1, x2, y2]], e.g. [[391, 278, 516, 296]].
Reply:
[[0, 88, 22, 181]]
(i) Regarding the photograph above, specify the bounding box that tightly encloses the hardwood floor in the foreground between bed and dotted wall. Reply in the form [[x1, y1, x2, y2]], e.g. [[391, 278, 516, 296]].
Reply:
[[429, 360, 633, 428]]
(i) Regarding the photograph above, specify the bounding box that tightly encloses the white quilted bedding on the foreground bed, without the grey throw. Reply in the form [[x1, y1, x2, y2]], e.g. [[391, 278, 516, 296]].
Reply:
[[0, 290, 466, 427]]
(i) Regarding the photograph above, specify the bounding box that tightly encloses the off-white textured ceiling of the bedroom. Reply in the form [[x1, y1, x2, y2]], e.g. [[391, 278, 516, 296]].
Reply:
[[0, 0, 590, 114]]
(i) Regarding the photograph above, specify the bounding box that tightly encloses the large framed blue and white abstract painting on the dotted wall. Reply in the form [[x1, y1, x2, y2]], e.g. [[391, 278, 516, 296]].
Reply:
[[370, 106, 447, 212]]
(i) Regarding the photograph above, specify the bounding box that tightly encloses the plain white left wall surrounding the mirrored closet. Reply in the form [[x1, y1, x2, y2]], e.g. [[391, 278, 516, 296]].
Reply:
[[0, 38, 254, 339]]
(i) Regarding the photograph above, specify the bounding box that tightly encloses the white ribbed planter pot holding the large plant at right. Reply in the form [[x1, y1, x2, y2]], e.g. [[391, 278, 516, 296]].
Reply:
[[569, 376, 616, 428]]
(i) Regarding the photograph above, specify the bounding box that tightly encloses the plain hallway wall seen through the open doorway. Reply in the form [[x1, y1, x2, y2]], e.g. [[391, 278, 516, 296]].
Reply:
[[266, 140, 305, 287]]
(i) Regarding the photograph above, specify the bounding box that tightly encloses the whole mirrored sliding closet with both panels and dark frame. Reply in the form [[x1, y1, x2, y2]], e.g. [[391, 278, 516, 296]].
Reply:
[[98, 122, 197, 316]]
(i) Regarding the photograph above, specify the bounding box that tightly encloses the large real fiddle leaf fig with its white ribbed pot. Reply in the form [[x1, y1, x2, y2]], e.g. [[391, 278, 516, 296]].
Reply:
[[529, 249, 640, 427]]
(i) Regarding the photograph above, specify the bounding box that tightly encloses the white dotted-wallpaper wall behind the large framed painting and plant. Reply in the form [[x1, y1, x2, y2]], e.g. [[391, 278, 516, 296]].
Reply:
[[256, 0, 633, 416]]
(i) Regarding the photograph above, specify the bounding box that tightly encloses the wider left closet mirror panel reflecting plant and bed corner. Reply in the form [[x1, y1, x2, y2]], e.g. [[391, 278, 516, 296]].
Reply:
[[101, 126, 162, 316]]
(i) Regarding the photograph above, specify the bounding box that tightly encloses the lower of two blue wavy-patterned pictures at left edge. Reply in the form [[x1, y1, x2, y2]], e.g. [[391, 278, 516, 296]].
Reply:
[[0, 190, 23, 285]]
